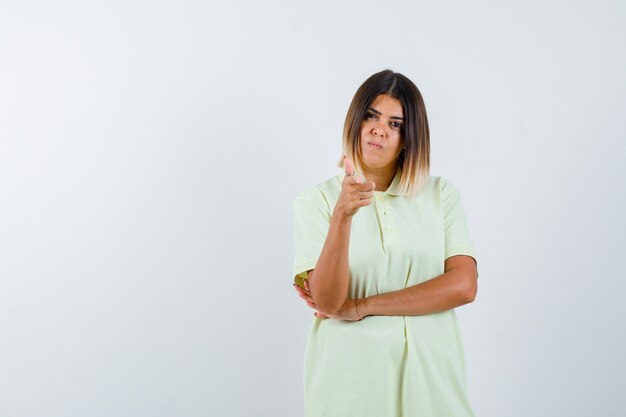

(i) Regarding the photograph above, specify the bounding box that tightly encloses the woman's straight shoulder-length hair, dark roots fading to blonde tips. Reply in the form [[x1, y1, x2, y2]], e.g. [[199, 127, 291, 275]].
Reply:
[[339, 70, 430, 197]]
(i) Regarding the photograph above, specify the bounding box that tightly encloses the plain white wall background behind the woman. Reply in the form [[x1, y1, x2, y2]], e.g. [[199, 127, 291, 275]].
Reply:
[[0, 0, 626, 417]]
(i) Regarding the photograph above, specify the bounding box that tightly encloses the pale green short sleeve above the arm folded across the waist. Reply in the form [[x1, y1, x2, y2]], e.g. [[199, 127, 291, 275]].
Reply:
[[441, 178, 476, 260]]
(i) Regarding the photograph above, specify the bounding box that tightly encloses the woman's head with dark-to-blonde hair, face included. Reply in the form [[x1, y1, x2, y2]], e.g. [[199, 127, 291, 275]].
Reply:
[[340, 70, 430, 195]]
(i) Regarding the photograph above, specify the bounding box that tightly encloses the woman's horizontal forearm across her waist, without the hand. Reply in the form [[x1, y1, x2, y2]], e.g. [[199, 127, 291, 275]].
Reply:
[[358, 271, 475, 317]]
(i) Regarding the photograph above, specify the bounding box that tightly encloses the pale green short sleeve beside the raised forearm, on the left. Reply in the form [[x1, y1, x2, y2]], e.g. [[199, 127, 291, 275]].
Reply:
[[293, 189, 331, 286]]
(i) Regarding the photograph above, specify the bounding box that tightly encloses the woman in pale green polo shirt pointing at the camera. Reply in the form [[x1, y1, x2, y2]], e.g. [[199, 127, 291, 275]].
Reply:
[[294, 70, 478, 417]]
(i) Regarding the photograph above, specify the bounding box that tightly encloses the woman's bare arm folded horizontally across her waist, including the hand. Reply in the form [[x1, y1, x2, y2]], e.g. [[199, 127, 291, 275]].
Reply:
[[296, 255, 478, 320]]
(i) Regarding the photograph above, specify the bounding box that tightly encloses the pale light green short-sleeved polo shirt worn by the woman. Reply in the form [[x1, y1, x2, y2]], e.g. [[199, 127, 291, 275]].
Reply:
[[294, 171, 476, 417]]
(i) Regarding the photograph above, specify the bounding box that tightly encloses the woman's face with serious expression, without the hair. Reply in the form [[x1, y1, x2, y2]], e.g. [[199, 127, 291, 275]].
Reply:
[[360, 94, 404, 170]]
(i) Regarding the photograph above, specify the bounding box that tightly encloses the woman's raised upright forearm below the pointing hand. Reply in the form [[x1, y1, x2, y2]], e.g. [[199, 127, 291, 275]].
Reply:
[[309, 210, 352, 313]]
